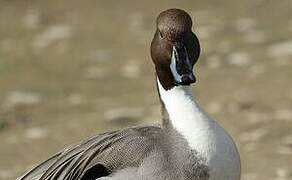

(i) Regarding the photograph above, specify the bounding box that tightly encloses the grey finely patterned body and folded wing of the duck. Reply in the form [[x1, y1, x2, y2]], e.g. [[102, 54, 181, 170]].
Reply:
[[19, 126, 208, 180]]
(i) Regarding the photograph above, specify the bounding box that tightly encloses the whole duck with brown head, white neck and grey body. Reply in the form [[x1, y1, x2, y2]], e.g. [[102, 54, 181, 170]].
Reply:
[[19, 9, 240, 180]]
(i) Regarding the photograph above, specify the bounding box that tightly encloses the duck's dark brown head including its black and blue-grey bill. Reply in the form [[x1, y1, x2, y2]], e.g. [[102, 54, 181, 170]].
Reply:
[[151, 9, 200, 90]]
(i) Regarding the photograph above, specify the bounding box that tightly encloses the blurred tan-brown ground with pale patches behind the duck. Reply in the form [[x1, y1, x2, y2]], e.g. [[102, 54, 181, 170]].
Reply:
[[0, 0, 292, 180]]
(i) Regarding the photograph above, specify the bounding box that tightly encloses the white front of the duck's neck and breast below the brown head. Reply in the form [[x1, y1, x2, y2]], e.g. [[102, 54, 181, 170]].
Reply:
[[157, 79, 240, 180]]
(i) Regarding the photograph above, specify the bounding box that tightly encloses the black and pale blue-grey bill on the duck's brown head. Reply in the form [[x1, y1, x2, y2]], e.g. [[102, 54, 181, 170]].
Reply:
[[170, 46, 196, 85]]
